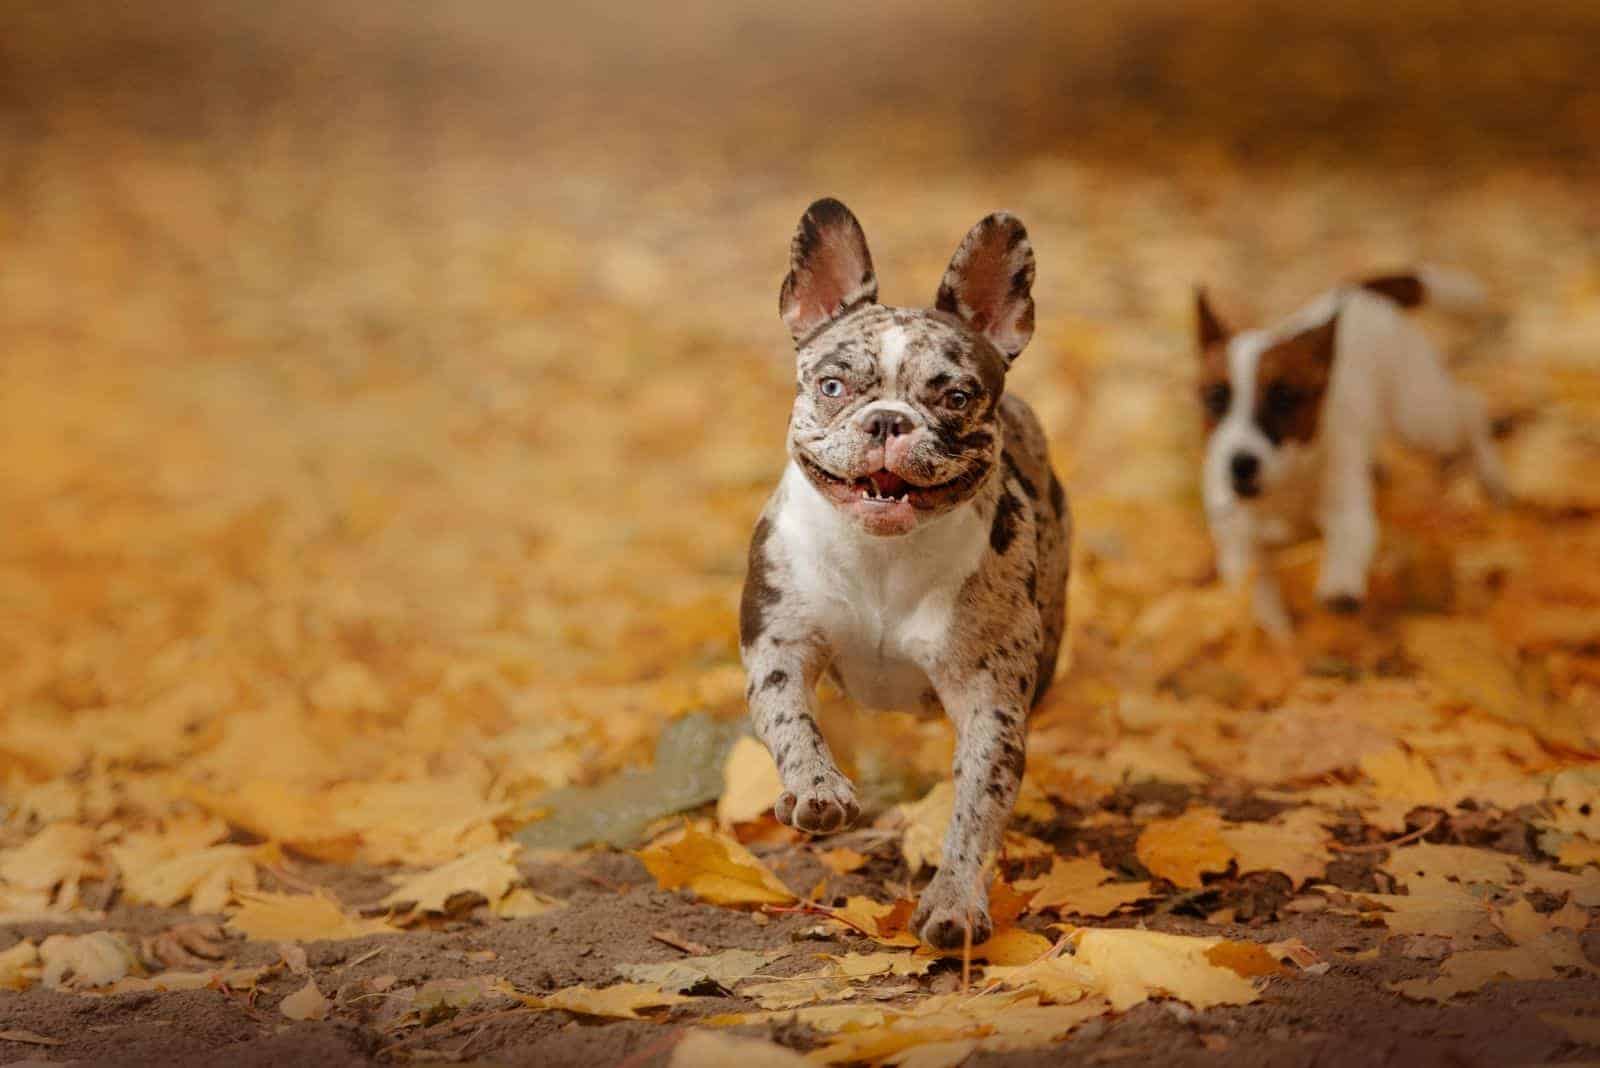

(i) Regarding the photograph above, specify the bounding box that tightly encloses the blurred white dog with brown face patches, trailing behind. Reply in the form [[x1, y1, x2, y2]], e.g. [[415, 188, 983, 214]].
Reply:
[[1195, 267, 1507, 638]]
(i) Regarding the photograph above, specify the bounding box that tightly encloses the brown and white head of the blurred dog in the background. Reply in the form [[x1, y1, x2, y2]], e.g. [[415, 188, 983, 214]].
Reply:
[[1195, 289, 1339, 508]]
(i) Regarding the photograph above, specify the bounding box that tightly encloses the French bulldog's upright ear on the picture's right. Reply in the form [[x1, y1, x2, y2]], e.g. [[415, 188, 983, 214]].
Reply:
[[934, 211, 1034, 363]]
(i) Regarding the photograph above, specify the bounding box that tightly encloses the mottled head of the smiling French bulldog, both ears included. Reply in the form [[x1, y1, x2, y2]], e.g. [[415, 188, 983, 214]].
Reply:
[[778, 200, 1034, 536]]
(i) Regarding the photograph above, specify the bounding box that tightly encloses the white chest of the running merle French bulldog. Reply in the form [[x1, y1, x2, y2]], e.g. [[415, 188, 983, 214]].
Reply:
[[774, 465, 987, 708]]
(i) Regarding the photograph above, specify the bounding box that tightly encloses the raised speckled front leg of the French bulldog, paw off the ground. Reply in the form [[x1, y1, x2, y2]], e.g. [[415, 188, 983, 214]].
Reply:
[[746, 641, 861, 835]]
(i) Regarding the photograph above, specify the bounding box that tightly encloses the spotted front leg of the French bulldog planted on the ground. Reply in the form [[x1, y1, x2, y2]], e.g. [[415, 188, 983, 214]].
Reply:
[[910, 684, 1034, 950]]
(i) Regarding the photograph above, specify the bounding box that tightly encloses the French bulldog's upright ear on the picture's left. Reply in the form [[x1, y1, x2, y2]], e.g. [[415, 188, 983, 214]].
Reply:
[[778, 197, 878, 345]]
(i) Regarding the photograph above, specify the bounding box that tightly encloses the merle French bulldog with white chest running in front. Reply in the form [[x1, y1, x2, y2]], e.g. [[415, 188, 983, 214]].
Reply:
[[739, 200, 1070, 948]]
